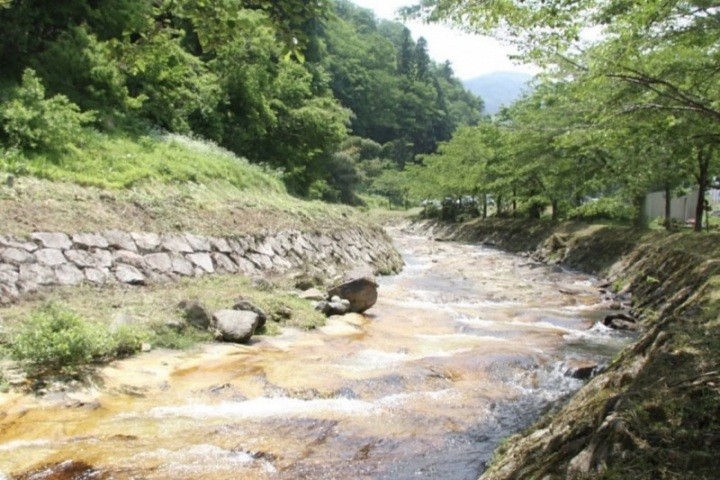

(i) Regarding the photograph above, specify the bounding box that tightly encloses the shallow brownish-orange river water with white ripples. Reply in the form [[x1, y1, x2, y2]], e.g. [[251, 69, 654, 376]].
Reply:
[[0, 233, 625, 479]]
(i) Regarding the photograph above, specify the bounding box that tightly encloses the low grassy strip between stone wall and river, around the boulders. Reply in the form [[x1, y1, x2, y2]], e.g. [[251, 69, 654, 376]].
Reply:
[[0, 275, 326, 382]]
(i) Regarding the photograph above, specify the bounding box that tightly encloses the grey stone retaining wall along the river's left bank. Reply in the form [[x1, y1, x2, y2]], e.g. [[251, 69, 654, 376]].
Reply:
[[0, 227, 402, 304]]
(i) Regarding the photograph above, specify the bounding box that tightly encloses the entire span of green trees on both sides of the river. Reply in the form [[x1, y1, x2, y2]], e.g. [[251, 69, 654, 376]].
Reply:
[[0, 0, 720, 230]]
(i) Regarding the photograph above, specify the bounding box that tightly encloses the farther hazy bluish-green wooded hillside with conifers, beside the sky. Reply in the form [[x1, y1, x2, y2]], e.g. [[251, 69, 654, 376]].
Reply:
[[322, 1, 482, 163]]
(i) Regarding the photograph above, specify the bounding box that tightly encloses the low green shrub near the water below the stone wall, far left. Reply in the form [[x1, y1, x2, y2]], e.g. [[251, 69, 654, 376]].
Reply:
[[9, 305, 112, 373]]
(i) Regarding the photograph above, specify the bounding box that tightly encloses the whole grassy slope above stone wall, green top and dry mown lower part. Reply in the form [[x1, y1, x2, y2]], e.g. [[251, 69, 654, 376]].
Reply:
[[0, 134, 372, 235]]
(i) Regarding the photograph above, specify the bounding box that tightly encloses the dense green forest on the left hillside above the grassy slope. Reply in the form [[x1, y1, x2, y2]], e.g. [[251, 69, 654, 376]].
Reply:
[[0, 0, 482, 204]]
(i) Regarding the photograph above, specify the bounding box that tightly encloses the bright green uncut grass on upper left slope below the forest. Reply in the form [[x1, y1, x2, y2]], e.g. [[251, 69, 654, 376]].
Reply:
[[0, 129, 285, 194]]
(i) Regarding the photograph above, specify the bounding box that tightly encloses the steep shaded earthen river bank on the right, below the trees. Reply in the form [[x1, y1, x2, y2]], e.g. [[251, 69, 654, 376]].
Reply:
[[415, 219, 720, 480]]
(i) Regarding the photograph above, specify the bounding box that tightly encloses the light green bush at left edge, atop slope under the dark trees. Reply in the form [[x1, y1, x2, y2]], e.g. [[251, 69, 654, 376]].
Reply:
[[0, 69, 94, 152]]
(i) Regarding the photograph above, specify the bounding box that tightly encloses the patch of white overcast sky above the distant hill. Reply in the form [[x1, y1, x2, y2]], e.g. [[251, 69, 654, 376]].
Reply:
[[351, 0, 537, 80]]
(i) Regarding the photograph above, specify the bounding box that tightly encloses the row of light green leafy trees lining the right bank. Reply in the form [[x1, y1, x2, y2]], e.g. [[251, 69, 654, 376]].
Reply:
[[396, 0, 720, 230]]
